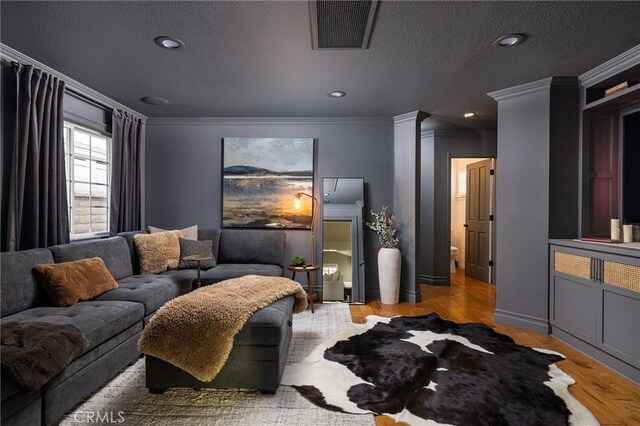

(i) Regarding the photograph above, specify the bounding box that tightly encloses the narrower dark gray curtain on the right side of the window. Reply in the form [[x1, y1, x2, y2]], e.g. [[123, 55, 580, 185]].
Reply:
[[110, 110, 144, 235]]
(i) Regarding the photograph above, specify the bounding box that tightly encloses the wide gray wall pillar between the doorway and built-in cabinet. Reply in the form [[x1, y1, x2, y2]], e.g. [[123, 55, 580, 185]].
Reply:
[[491, 79, 578, 333]]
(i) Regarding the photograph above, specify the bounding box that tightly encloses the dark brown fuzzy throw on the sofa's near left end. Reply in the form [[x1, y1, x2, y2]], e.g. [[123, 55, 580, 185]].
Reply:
[[0, 322, 89, 394]]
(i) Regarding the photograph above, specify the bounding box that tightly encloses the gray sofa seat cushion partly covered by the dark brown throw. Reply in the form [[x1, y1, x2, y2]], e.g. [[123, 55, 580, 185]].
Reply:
[[3, 300, 144, 352]]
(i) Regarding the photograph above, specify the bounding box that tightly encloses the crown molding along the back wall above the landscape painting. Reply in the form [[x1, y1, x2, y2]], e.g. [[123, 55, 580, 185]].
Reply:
[[147, 117, 391, 126]]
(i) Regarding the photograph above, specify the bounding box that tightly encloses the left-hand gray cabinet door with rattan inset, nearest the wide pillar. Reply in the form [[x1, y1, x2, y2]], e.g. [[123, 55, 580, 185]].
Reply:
[[549, 245, 599, 345]]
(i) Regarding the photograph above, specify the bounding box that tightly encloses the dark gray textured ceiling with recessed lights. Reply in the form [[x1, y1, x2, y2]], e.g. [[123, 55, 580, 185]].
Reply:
[[0, 1, 640, 128]]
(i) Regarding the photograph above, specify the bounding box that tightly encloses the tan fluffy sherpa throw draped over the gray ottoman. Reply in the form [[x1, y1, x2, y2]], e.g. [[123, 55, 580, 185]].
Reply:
[[138, 275, 307, 382]]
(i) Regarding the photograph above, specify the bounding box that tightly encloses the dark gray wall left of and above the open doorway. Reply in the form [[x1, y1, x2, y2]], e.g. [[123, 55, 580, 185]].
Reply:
[[418, 130, 499, 285]]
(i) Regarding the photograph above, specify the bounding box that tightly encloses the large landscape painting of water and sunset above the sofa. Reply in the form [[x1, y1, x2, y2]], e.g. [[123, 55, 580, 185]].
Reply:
[[222, 138, 313, 229]]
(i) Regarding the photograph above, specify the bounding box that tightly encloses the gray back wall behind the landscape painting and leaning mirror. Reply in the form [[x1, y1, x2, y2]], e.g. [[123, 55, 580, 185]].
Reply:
[[145, 118, 393, 299]]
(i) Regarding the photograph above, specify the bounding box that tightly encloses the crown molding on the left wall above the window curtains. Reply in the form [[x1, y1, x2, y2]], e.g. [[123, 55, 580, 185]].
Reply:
[[0, 43, 147, 120]]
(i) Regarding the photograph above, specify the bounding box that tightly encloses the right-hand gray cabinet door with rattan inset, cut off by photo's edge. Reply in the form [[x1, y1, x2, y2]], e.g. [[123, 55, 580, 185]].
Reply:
[[597, 253, 640, 367]]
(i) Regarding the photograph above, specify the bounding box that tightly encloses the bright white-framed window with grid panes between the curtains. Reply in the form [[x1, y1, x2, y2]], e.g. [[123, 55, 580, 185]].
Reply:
[[64, 122, 111, 239]]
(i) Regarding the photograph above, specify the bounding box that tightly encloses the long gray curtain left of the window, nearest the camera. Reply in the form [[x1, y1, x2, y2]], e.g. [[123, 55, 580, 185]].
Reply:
[[4, 64, 69, 251]]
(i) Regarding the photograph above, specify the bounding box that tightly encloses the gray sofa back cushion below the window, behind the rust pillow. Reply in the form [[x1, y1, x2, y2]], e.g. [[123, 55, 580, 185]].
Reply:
[[49, 237, 133, 280]]
